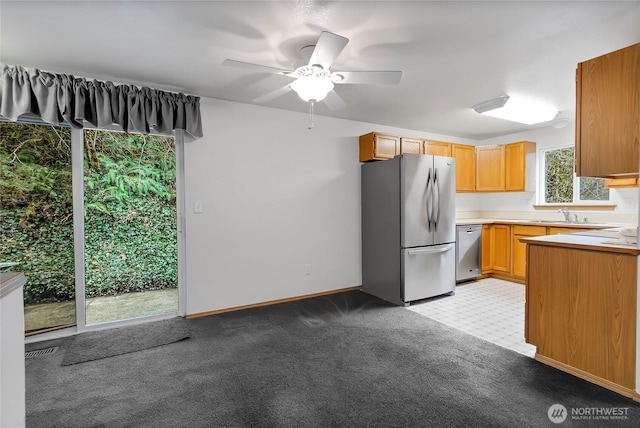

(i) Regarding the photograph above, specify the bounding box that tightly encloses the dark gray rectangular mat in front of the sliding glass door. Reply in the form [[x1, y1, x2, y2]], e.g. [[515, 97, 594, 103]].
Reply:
[[62, 317, 189, 366]]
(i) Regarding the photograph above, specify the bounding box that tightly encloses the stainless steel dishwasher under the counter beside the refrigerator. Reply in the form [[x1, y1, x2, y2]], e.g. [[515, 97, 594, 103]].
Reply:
[[456, 224, 482, 282]]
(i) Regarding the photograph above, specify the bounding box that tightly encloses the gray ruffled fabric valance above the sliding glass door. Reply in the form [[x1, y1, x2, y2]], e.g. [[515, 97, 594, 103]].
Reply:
[[0, 64, 202, 138]]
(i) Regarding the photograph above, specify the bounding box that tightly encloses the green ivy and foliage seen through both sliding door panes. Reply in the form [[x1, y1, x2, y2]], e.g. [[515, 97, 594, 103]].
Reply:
[[0, 122, 177, 304]]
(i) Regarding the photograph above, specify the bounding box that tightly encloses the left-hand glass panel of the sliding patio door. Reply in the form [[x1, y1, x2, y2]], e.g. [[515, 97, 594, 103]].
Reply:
[[0, 122, 76, 334]]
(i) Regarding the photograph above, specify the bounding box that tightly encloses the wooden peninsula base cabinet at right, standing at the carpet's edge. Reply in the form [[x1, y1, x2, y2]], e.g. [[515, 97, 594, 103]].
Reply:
[[525, 241, 638, 400]]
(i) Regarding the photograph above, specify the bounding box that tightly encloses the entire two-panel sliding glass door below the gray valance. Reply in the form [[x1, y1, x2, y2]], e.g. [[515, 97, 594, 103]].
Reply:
[[0, 122, 182, 334]]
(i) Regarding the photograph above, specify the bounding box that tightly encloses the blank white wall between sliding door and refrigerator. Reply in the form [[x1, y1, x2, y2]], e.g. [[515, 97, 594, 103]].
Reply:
[[185, 98, 470, 314]]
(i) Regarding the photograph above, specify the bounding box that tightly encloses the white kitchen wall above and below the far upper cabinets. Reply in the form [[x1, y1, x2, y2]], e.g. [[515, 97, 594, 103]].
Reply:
[[457, 122, 638, 223]]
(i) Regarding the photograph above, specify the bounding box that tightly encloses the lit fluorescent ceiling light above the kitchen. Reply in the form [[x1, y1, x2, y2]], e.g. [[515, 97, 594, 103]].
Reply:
[[473, 95, 558, 125]]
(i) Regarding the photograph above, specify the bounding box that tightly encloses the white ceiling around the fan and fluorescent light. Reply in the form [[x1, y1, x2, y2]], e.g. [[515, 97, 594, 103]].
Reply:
[[0, 0, 640, 140]]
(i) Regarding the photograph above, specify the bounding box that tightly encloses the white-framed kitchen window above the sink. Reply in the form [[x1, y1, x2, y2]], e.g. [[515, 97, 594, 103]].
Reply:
[[538, 146, 609, 205]]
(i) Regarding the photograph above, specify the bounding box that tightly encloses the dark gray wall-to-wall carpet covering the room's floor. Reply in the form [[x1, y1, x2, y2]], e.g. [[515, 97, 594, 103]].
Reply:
[[26, 291, 640, 428]]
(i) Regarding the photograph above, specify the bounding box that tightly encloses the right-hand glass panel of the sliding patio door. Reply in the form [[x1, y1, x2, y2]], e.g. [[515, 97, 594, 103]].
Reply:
[[84, 130, 178, 325]]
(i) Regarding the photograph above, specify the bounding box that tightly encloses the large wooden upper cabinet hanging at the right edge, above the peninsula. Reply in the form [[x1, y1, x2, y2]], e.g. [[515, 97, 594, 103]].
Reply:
[[575, 43, 640, 177]]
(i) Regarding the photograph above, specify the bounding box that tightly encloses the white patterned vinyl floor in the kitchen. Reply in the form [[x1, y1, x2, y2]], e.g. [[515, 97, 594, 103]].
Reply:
[[407, 278, 535, 358]]
